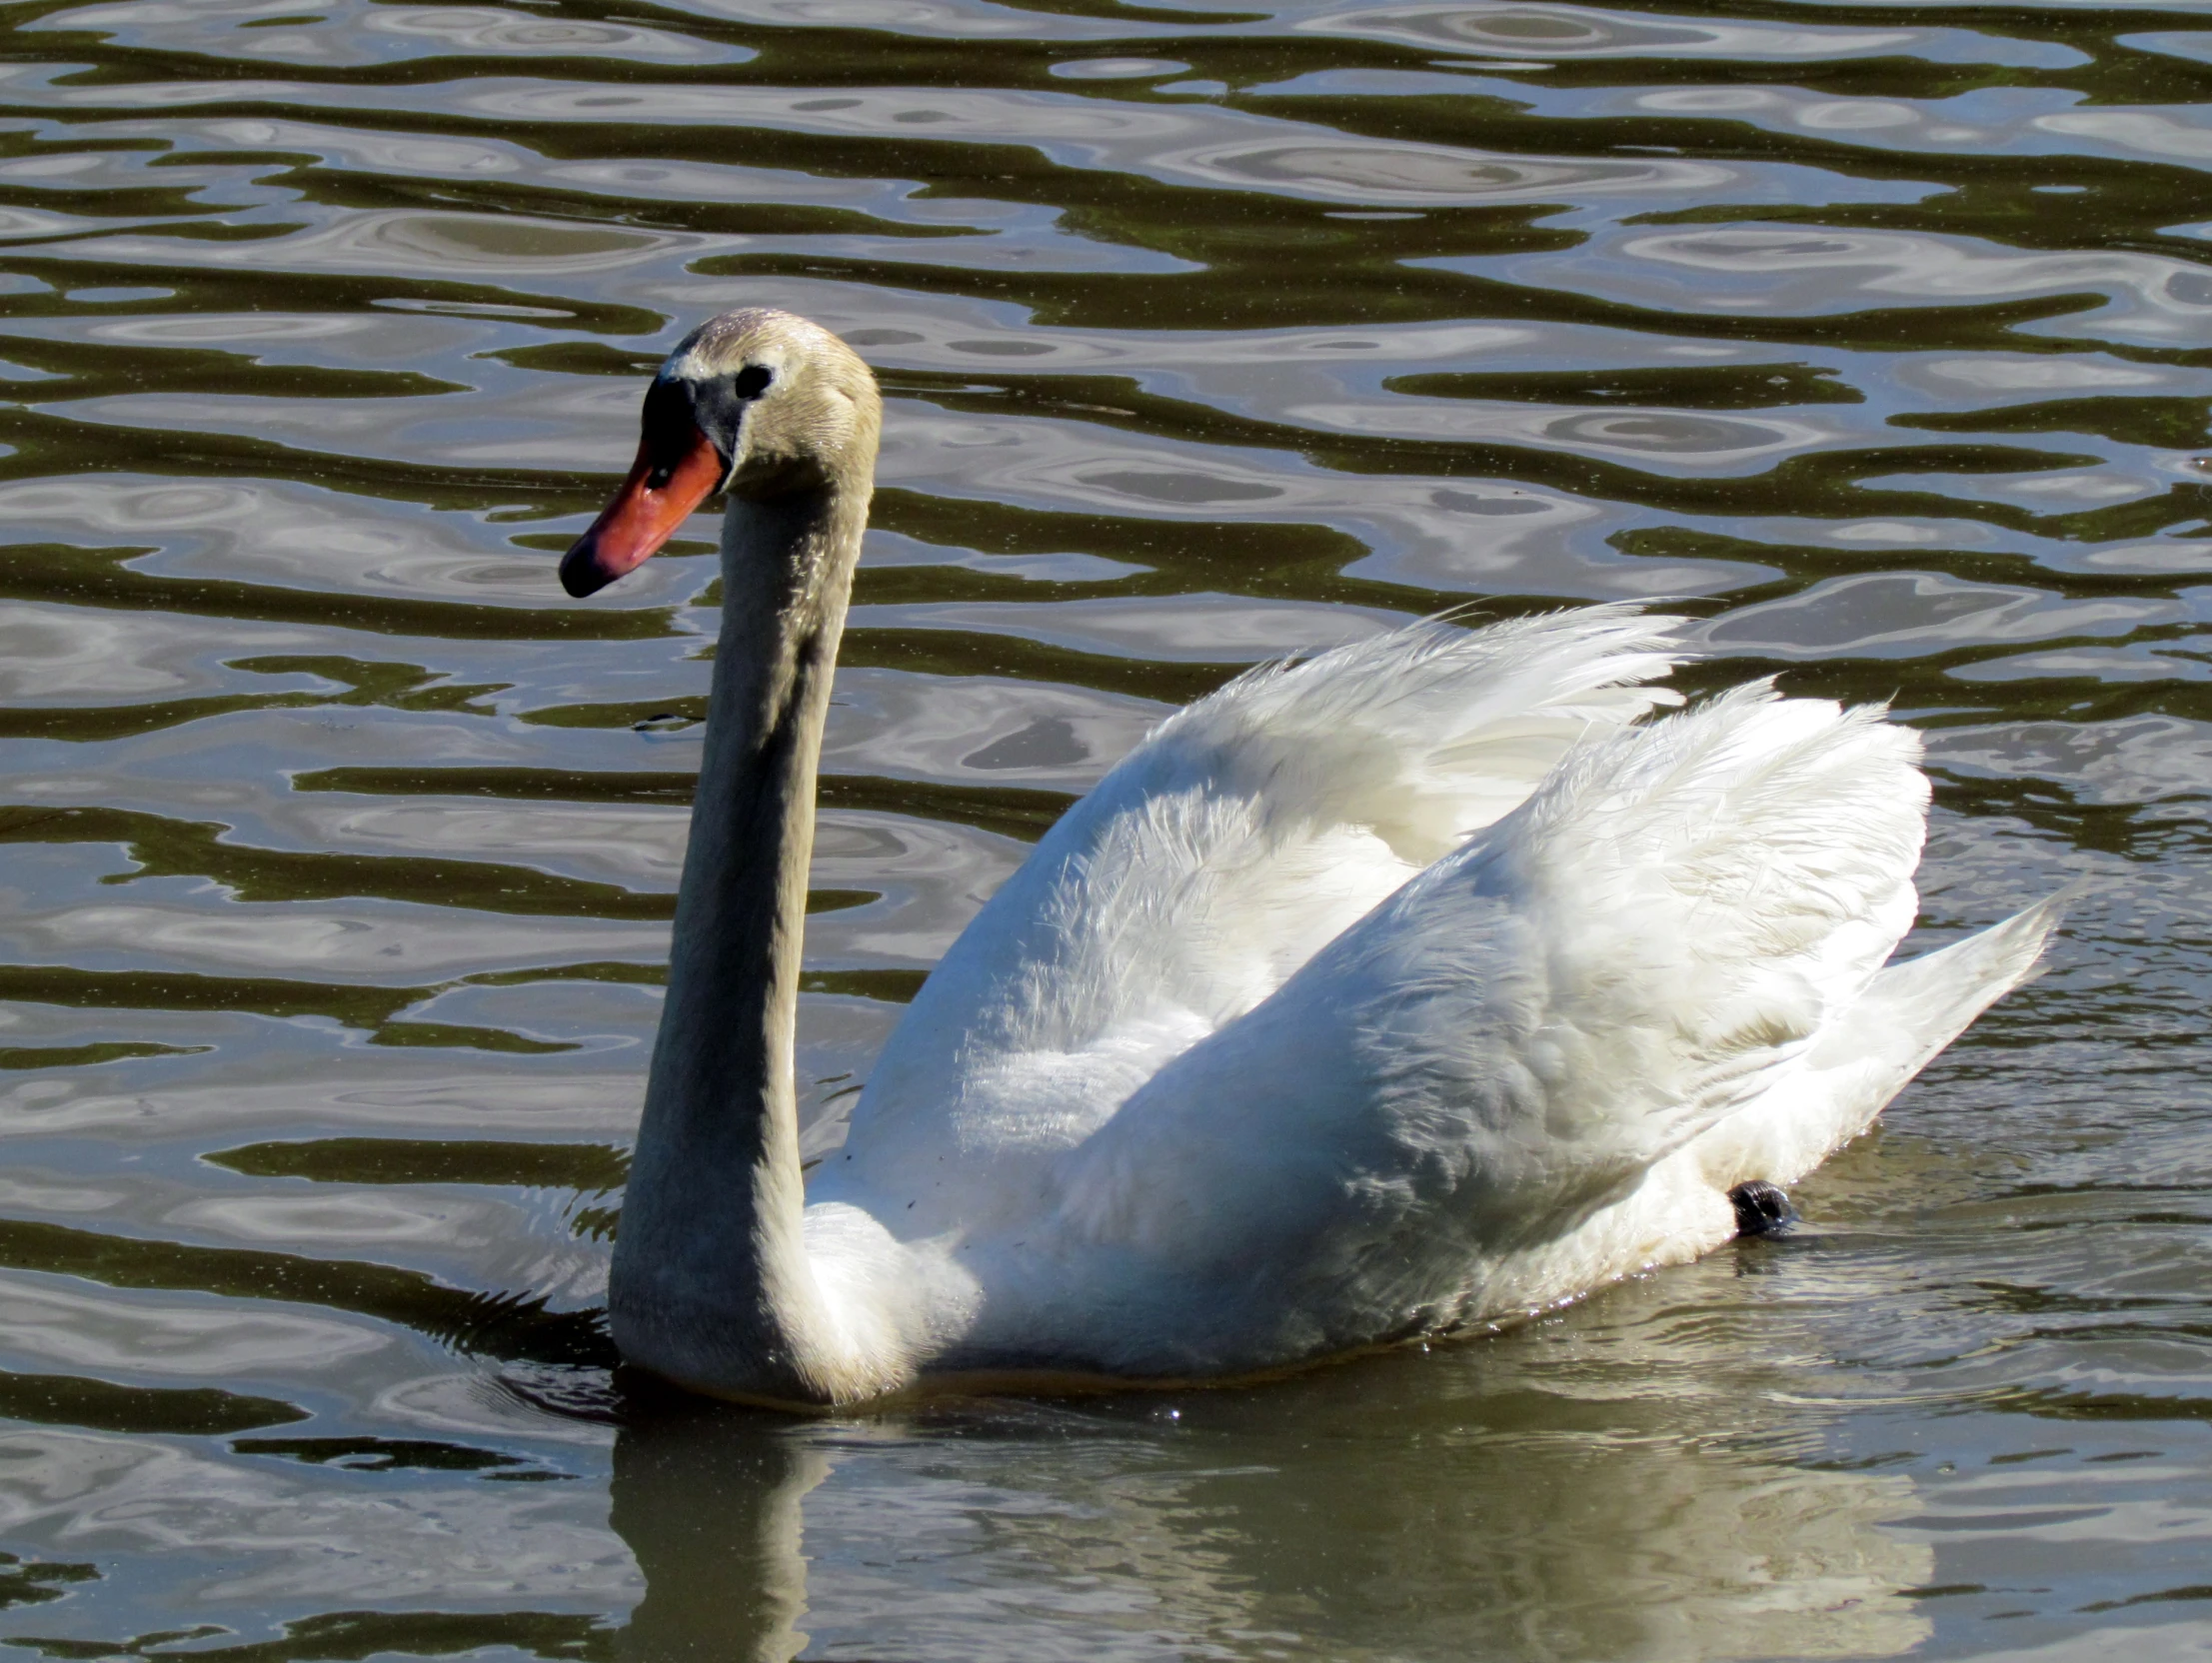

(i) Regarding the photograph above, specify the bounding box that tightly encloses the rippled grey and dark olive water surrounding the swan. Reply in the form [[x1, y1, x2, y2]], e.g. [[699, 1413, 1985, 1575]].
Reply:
[[0, 0, 2212, 1663]]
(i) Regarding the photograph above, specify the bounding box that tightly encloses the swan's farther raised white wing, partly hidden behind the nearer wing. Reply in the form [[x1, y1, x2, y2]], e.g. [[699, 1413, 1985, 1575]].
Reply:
[[825, 606, 1679, 1229]]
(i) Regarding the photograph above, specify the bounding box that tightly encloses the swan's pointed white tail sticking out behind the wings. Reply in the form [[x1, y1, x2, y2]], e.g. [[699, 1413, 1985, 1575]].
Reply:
[[1696, 884, 2081, 1189]]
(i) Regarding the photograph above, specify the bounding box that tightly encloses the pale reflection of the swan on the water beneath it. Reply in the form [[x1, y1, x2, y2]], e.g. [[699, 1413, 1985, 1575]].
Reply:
[[613, 1256, 1933, 1663]]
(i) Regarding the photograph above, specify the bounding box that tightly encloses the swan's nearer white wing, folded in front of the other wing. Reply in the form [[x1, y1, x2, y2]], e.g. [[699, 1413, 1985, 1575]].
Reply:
[[1022, 686, 1927, 1373]]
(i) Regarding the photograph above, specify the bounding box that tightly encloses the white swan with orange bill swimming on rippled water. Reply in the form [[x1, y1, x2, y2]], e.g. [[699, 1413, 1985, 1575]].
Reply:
[[560, 310, 2057, 1409]]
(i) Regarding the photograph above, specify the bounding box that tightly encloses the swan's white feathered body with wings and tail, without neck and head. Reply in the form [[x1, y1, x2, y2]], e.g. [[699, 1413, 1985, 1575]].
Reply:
[[806, 609, 2048, 1378]]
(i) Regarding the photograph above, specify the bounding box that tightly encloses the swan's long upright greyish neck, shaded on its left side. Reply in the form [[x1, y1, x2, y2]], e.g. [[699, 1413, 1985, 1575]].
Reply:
[[609, 480, 867, 1402]]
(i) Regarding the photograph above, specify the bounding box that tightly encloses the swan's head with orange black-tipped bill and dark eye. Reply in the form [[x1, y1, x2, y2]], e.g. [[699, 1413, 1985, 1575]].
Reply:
[[560, 308, 883, 595]]
